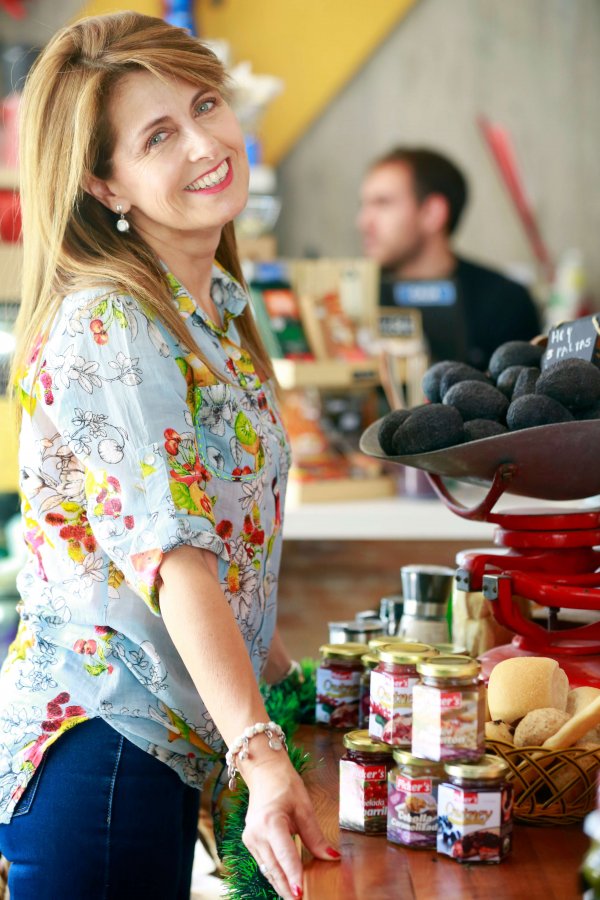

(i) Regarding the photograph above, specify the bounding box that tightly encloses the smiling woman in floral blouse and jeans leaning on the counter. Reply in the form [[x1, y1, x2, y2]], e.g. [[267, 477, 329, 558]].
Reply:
[[0, 13, 336, 900]]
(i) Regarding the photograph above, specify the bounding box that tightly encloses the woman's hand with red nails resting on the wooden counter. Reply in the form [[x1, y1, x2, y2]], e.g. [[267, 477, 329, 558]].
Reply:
[[239, 735, 340, 900]]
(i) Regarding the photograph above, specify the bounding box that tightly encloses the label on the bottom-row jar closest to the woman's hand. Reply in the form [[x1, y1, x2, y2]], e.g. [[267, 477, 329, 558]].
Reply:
[[340, 759, 388, 832]]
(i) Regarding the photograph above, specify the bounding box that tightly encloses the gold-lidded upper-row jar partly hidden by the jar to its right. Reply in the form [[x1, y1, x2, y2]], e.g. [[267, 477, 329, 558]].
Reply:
[[369, 643, 436, 748]]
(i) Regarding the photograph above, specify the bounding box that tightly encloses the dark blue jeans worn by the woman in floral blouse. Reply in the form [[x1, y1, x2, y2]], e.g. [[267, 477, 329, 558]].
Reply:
[[0, 719, 200, 900]]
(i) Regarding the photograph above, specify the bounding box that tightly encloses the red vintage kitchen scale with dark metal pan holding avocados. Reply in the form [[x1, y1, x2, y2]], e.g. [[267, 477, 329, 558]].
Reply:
[[361, 420, 600, 687]]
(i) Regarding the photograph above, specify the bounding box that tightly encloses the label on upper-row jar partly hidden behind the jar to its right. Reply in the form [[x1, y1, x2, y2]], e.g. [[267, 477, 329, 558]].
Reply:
[[369, 670, 419, 747]]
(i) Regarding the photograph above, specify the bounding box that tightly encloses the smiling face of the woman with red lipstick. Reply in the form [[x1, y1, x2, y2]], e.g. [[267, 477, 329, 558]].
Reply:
[[106, 71, 248, 243]]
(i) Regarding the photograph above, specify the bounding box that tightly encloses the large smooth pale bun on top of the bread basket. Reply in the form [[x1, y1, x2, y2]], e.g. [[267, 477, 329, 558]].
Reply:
[[488, 656, 569, 722]]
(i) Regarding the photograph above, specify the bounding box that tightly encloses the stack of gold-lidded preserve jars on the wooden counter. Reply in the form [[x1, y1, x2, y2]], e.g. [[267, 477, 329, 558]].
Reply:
[[317, 638, 512, 863]]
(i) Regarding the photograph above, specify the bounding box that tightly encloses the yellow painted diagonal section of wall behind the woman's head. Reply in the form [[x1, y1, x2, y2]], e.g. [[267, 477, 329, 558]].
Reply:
[[76, 0, 416, 164]]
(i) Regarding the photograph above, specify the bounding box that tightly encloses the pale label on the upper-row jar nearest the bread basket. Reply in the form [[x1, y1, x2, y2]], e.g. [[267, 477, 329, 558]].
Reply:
[[412, 684, 485, 760]]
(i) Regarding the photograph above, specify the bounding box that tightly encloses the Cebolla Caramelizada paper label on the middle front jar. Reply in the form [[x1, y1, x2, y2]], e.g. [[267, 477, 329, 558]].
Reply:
[[387, 775, 439, 847]]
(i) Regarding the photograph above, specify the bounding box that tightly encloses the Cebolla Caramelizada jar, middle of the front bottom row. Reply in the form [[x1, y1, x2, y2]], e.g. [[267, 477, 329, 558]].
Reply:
[[387, 750, 444, 849]]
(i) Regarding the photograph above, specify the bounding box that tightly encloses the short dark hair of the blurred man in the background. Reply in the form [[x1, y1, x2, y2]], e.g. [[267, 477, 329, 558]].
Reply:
[[371, 147, 469, 234]]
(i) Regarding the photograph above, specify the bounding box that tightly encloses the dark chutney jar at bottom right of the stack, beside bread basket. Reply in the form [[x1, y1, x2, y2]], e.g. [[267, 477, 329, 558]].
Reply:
[[437, 753, 513, 863]]
